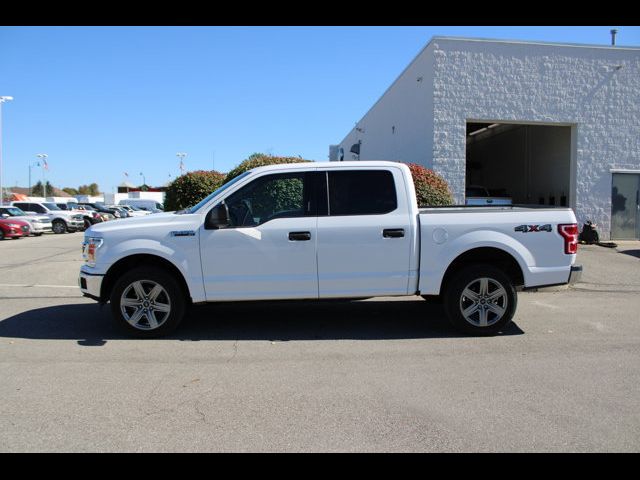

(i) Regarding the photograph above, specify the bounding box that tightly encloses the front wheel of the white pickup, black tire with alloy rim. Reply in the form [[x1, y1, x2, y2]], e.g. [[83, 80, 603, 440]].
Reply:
[[110, 267, 187, 338]]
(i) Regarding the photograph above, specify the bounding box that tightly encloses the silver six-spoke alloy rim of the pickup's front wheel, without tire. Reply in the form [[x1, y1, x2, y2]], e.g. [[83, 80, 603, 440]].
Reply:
[[120, 280, 171, 330]]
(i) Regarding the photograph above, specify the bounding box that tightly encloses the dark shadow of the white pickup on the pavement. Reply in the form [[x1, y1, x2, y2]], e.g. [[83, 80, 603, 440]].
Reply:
[[0, 299, 524, 346]]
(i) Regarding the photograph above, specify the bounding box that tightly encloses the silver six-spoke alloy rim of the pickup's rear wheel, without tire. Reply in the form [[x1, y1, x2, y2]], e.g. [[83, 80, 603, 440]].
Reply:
[[460, 277, 509, 327]]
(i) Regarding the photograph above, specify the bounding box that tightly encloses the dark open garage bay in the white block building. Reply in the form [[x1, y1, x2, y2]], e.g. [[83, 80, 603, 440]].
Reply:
[[466, 121, 573, 206]]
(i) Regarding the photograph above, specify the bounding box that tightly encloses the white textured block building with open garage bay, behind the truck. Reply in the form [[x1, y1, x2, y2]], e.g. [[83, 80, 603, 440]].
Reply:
[[329, 37, 640, 239]]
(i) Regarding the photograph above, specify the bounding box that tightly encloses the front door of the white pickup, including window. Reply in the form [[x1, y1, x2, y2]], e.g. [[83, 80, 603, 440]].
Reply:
[[200, 172, 318, 301]]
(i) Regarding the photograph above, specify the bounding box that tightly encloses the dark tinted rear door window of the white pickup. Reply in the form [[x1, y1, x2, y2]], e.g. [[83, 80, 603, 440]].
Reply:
[[329, 170, 398, 215]]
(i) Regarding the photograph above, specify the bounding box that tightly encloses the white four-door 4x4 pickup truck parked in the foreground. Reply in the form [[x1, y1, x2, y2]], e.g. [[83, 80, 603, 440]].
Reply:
[[79, 161, 582, 337]]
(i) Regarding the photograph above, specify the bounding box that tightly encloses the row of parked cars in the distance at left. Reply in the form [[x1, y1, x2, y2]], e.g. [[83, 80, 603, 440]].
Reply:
[[0, 201, 161, 240]]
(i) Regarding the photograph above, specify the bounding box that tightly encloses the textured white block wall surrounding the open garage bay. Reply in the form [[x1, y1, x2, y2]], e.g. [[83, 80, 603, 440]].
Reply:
[[431, 38, 640, 238]]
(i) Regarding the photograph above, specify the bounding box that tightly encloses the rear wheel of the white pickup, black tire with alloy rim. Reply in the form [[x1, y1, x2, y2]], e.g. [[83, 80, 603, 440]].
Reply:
[[444, 264, 518, 335]]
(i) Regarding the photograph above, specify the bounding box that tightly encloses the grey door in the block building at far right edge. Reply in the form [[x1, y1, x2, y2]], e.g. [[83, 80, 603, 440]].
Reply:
[[611, 173, 640, 240]]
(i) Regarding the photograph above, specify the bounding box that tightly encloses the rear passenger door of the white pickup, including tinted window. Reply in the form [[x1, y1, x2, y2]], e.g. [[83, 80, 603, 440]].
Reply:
[[318, 167, 412, 298]]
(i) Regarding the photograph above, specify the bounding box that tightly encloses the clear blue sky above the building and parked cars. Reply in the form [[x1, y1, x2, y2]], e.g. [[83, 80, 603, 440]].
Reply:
[[0, 25, 640, 192]]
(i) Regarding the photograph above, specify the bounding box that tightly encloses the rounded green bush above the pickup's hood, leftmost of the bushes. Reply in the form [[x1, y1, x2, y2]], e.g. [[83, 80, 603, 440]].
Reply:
[[164, 170, 225, 212]]
